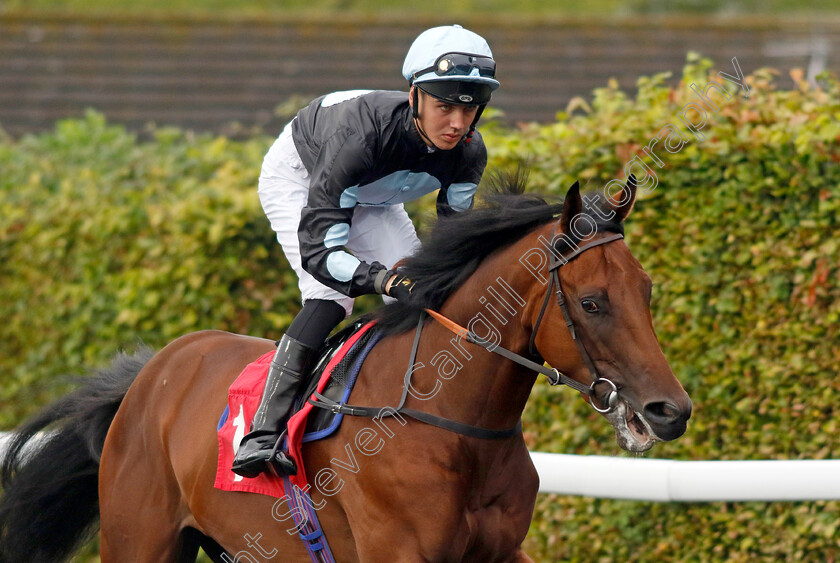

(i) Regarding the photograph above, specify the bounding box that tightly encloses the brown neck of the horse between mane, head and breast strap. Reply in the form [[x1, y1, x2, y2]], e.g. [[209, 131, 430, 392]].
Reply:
[[412, 249, 535, 429]]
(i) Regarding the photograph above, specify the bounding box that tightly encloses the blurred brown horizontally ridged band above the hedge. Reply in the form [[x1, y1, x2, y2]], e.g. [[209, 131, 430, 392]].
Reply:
[[0, 15, 840, 135]]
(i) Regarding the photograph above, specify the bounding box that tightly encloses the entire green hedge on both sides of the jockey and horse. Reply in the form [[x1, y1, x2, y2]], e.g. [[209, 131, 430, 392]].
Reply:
[[0, 56, 840, 562]]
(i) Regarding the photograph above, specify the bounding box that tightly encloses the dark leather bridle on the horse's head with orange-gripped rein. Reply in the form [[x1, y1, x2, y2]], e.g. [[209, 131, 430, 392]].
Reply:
[[426, 229, 624, 413]]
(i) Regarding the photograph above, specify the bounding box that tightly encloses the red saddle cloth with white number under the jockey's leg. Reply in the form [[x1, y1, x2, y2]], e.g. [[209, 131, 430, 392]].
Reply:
[[214, 323, 374, 498]]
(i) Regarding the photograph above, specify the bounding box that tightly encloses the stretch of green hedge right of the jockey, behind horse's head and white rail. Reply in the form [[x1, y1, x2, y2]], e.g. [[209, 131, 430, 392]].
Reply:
[[486, 55, 840, 562]]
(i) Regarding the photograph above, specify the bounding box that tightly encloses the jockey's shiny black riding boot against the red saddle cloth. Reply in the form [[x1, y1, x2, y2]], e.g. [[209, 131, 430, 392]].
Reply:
[[232, 335, 317, 477]]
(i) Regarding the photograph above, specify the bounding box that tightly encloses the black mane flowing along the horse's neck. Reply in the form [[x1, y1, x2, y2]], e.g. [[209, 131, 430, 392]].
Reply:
[[373, 170, 621, 334]]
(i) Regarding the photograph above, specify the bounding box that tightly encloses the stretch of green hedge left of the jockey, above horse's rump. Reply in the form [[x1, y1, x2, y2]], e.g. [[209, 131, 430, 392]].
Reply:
[[0, 119, 296, 426]]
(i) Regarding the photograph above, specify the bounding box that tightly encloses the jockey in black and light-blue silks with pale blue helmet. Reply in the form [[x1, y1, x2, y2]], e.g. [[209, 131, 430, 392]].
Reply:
[[233, 25, 499, 477]]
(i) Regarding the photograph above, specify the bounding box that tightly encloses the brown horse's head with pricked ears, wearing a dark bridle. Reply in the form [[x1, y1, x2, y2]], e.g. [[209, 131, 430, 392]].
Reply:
[[529, 177, 691, 452]]
